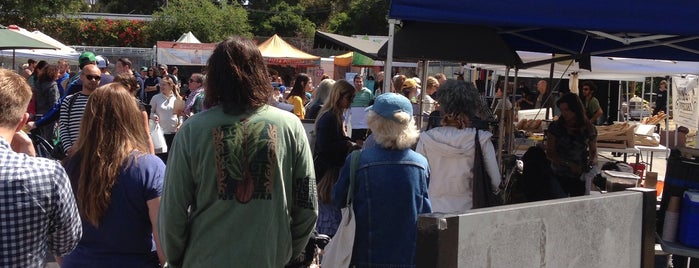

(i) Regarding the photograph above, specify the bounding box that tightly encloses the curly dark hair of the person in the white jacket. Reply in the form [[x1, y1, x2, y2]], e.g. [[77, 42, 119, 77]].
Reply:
[[437, 79, 485, 119]]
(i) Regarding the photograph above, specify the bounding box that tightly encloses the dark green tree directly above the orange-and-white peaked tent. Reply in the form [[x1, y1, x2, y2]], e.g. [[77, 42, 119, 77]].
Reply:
[[255, 2, 315, 37]]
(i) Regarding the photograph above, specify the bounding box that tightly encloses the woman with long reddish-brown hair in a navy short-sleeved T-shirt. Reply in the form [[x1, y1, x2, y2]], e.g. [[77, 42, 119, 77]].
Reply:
[[61, 83, 165, 267]]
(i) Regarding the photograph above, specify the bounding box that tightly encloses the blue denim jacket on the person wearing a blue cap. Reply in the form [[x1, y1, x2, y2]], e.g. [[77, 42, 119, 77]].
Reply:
[[333, 146, 432, 267]]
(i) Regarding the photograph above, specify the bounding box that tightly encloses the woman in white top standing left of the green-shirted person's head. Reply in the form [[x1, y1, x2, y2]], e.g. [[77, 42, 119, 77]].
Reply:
[[150, 76, 184, 163]]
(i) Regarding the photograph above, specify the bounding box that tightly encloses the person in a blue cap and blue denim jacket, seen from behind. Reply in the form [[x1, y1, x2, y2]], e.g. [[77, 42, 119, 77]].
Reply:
[[332, 93, 432, 267]]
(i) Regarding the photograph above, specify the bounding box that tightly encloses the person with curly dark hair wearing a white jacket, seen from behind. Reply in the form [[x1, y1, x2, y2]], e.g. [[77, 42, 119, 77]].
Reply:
[[415, 79, 501, 213]]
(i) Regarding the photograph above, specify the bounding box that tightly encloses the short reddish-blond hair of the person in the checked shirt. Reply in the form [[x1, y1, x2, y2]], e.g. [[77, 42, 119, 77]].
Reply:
[[0, 68, 32, 128]]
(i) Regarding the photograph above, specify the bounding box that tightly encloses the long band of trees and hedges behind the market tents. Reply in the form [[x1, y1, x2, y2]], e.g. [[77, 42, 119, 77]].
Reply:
[[0, 0, 390, 47]]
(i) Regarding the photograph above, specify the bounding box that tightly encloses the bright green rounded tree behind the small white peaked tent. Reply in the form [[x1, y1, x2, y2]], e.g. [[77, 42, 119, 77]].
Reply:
[[149, 0, 252, 43]]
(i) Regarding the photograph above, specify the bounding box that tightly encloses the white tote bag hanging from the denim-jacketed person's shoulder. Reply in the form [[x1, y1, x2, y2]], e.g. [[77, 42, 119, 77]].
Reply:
[[320, 150, 361, 268]]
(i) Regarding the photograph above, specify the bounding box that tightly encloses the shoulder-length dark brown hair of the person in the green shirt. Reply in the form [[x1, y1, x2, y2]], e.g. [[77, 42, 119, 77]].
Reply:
[[204, 36, 272, 115]]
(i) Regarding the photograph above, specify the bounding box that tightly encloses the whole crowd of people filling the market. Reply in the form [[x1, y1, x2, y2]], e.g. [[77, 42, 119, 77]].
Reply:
[[0, 34, 608, 267]]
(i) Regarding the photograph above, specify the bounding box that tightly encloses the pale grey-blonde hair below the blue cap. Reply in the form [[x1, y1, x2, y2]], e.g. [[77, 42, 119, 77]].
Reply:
[[366, 110, 420, 150]]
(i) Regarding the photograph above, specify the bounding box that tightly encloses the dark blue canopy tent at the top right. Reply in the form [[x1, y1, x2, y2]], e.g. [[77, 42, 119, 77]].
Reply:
[[386, 0, 699, 203]]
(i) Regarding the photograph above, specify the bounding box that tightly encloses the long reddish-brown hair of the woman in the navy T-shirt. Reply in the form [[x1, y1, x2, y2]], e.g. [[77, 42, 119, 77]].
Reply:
[[75, 83, 149, 226]]
